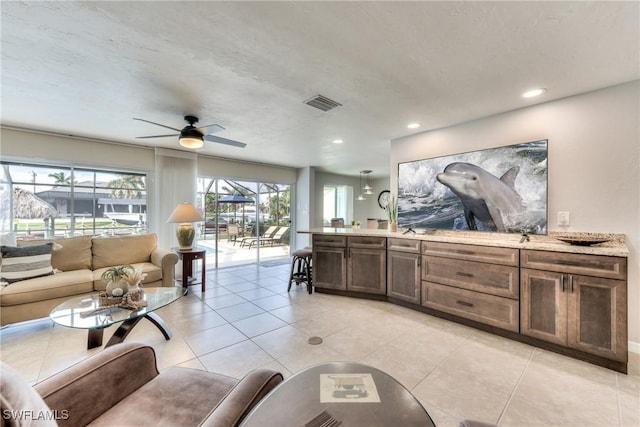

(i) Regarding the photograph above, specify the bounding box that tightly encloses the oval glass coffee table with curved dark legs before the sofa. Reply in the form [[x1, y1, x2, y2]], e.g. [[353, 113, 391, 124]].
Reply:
[[49, 287, 185, 349]]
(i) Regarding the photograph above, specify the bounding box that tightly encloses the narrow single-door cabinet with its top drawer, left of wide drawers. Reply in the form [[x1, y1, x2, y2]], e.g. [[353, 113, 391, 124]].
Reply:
[[387, 238, 421, 305]]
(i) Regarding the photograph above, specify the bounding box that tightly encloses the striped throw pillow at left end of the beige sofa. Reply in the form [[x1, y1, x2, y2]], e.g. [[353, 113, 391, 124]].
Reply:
[[0, 243, 53, 283]]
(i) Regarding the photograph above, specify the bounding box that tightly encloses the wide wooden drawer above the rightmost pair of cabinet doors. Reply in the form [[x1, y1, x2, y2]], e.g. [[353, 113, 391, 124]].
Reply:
[[520, 250, 627, 280]]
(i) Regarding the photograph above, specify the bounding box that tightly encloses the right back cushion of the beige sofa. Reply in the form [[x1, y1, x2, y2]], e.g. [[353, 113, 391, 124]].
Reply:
[[92, 233, 158, 270]]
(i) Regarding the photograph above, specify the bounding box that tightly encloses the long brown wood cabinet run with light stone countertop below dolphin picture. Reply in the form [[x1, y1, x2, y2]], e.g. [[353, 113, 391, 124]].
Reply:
[[304, 228, 629, 372]]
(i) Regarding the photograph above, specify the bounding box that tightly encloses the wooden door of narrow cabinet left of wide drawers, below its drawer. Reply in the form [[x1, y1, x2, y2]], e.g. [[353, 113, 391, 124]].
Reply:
[[387, 251, 420, 304]]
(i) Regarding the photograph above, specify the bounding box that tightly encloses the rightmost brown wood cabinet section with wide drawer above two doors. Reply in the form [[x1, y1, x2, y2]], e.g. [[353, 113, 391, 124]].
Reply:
[[520, 250, 628, 362]]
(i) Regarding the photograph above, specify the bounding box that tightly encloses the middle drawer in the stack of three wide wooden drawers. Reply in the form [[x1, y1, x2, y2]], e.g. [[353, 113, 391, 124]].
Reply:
[[422, 255, 520, 299]]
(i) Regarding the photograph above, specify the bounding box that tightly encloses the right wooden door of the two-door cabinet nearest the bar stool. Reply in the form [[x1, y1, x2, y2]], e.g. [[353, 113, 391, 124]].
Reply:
[[347, 248, 387, 295]]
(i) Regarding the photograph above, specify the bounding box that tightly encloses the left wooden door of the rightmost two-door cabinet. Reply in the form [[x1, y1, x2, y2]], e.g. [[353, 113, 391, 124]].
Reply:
[[520, 268, 567, 345]]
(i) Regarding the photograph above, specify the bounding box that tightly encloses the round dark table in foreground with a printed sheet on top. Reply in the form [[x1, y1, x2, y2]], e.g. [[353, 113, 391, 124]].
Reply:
[[241, 362, 435, 427]]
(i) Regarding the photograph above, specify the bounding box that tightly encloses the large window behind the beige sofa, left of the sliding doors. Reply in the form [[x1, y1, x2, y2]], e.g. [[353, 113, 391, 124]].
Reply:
[[0, 162, 147, 239]]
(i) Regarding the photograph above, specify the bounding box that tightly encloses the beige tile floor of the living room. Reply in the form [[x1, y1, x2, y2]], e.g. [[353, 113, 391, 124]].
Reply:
[[0, 264, 640, 427]]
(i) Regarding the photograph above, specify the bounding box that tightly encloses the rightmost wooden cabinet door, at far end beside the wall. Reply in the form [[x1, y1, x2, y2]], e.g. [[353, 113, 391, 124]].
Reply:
[[567, 275, 627, 362]]
